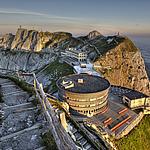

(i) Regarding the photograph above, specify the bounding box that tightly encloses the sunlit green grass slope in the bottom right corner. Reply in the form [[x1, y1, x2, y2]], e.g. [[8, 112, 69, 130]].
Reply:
[[116, 115, 150, 150]]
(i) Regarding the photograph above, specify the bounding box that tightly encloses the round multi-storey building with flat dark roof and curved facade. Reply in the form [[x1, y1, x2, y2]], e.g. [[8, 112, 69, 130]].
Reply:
[[57, 74, 110, 116]]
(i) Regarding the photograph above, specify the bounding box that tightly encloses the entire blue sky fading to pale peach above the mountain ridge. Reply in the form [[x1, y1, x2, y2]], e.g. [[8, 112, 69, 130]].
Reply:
[[0, 0, 150, 35]]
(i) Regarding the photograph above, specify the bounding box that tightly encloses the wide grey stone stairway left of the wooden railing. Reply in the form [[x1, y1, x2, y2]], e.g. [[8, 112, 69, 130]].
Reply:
[[0, 78, 46, 150]]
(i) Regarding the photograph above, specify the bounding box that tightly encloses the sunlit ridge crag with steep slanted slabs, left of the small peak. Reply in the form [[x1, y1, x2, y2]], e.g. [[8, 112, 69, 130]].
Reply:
[[11, 28, 72, 51]]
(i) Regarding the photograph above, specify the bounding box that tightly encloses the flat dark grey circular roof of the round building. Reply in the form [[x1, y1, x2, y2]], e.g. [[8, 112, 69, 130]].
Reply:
[[57, 74, 110, 93]]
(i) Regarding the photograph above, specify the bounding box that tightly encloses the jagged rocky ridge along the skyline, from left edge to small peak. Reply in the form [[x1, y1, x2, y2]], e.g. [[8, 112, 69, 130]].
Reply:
[[0, 28, 104, 52]]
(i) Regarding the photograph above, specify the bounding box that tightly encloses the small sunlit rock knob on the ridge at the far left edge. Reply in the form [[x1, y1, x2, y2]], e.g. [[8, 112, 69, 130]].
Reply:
[[0, 33, 14, 49]]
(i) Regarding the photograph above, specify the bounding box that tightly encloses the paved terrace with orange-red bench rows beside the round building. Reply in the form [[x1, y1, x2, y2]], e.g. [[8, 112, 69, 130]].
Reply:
[[73, 94, 138, 137]]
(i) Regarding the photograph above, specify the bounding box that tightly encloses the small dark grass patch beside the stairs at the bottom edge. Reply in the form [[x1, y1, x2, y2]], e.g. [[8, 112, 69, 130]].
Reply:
[[42, 131, 58, 150]]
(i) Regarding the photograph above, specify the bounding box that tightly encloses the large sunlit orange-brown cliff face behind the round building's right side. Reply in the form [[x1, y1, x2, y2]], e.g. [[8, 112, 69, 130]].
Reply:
[[94, 38, 150, 95]]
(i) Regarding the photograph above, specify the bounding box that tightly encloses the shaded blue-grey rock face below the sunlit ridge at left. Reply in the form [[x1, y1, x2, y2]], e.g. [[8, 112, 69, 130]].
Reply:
[[0, 50, 57, 72]]
